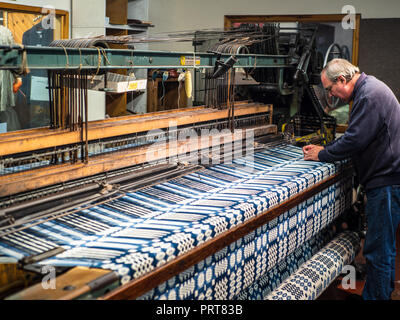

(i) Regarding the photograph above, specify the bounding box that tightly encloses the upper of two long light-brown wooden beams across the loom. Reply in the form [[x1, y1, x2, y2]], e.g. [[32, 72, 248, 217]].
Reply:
[[0, 104, 272, 156]]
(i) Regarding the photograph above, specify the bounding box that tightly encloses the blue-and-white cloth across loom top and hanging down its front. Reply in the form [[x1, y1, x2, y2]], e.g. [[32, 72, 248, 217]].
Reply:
[[0, 144, 352, 299]]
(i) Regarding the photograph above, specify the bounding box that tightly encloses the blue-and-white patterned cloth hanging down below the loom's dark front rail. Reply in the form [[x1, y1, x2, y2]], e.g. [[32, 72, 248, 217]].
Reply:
[[141, 182, 354, 300]]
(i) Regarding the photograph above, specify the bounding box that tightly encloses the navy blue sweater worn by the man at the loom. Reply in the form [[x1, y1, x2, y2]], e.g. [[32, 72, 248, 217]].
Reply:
[[318, 73, 400, 189]]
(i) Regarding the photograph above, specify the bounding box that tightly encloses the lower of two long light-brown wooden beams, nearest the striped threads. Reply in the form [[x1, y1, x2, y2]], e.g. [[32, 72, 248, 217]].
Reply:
[[0, 125, 276, 197]]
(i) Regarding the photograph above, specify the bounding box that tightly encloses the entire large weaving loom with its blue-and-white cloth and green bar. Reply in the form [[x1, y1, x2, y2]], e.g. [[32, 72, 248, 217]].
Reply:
[[0, 24, 359, 299]]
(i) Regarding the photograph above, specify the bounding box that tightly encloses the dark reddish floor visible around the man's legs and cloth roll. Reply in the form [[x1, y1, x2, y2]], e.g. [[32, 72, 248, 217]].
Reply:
[[317, 228, 400, 300]]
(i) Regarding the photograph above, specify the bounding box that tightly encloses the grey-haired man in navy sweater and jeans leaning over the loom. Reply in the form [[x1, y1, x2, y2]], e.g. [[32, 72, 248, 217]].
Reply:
[[303, 59, 400, 300]]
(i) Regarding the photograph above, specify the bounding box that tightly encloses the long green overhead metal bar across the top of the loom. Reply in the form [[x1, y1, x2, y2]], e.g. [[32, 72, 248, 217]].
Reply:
[[0, 45, 291, 72]]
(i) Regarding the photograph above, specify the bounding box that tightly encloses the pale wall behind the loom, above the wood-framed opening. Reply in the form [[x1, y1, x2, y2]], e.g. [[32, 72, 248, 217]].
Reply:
[[149, 0, 400, 51]]
